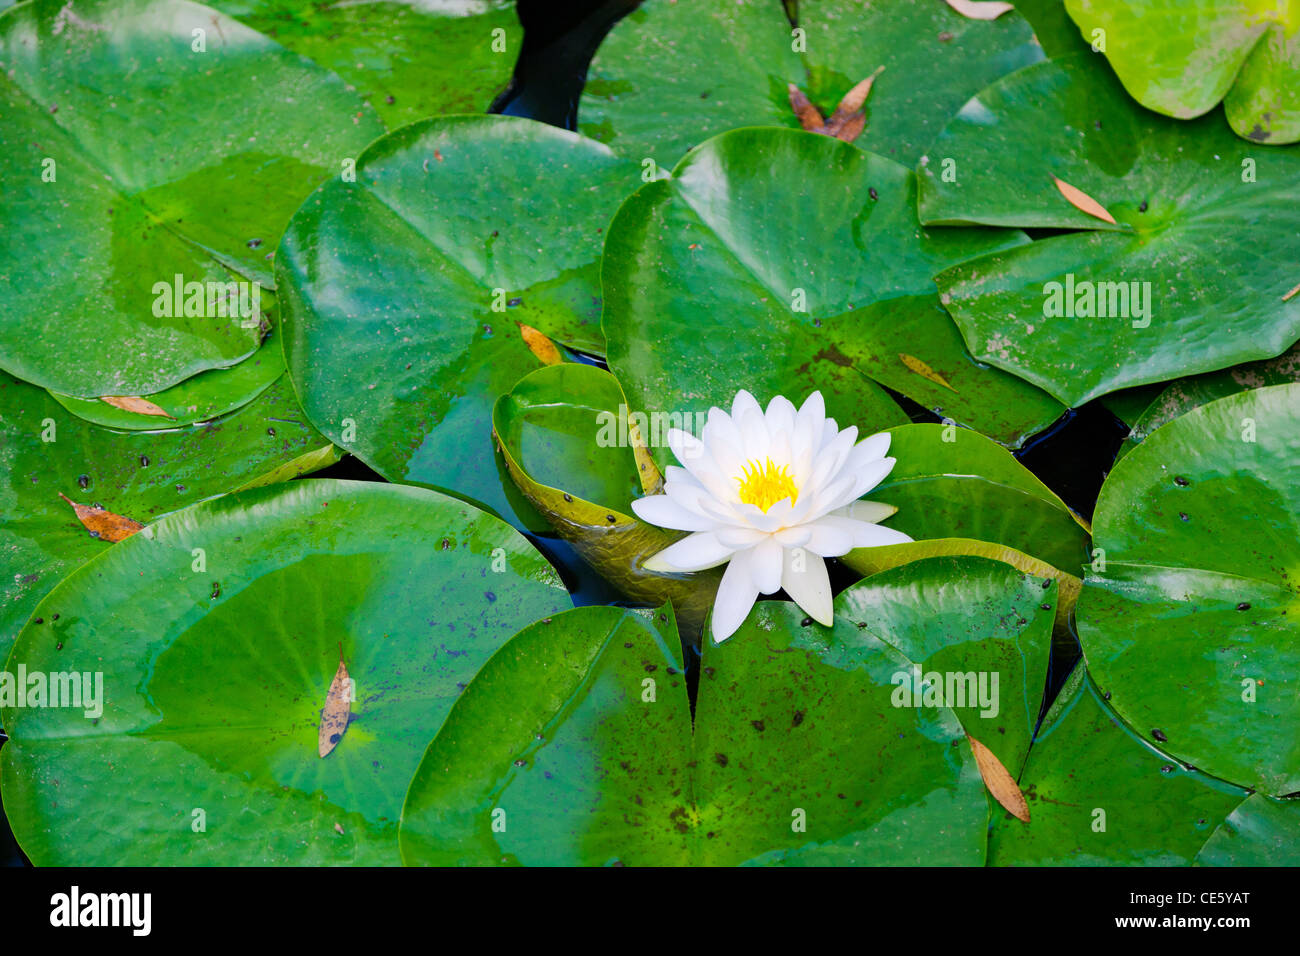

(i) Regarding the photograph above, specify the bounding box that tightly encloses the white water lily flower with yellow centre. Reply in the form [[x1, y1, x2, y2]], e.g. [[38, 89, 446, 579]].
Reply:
[[632, 390, 911, 644]]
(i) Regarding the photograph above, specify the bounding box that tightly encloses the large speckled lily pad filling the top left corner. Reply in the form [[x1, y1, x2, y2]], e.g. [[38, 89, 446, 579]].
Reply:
[[0, 0, 382, 398]]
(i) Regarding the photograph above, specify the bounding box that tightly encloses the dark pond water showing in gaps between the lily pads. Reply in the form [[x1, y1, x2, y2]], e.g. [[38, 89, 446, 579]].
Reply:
[[0, 0, 1128, 866]]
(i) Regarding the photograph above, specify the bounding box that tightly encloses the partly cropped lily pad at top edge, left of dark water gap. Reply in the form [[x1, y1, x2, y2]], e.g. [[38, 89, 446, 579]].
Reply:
[[212, 0, 523, 129]]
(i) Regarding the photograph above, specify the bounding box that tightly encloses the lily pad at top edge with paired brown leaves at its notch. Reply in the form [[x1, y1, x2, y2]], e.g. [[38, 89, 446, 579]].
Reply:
[[579, 0, 1043, 168]]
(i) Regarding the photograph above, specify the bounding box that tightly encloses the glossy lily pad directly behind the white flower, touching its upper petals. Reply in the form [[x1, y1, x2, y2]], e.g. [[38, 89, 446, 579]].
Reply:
[[602, 130, 1063, 452]]
